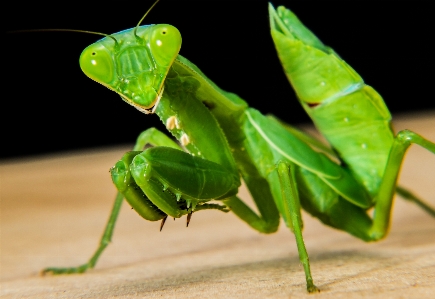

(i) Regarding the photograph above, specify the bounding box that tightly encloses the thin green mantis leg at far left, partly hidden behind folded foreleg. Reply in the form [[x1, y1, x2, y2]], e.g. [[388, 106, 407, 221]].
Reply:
[[41, 128, 180, 275]]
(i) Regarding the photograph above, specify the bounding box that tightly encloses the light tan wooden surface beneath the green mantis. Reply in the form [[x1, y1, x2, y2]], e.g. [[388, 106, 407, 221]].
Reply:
[[1, 111, 435, 298]]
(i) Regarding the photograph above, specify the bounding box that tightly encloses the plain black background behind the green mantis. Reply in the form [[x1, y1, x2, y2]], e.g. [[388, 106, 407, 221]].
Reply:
[[4, 0, 435, 159]]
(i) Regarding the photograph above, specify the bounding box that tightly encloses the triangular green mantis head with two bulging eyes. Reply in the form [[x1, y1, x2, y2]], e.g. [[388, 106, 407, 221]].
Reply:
[[80, 24, 181, 113]]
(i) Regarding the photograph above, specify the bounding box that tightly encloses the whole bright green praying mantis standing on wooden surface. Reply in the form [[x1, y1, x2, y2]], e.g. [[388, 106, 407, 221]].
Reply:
[[17, 0, 435, 292]]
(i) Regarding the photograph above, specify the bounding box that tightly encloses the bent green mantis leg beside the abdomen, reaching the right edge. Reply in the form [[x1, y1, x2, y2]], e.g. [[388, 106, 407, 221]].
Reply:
[[370, 130, 435, 240]]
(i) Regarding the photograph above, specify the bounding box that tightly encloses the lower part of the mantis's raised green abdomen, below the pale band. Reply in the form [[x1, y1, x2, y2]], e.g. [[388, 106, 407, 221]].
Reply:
[[305, 85, 394, 196]]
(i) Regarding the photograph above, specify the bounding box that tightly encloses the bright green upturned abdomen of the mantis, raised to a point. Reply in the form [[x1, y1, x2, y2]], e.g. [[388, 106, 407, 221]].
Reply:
[[271, 7, 394, 197]]
